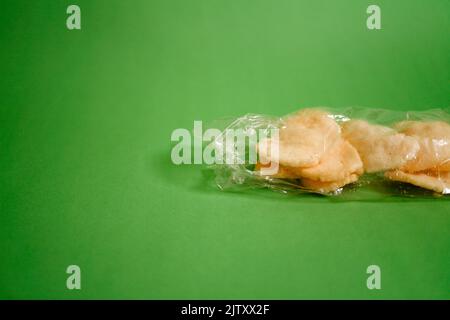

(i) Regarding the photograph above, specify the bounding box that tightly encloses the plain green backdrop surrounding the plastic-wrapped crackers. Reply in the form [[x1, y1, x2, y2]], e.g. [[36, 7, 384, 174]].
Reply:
[[0, 0, 450, 299]]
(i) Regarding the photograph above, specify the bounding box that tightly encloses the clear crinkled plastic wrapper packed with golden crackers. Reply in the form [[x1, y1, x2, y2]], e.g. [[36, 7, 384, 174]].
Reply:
[[210, 107, 450, 199]]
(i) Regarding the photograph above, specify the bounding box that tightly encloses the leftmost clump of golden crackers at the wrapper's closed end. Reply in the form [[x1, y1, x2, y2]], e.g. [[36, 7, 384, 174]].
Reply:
[[256, 109, 363, 193]]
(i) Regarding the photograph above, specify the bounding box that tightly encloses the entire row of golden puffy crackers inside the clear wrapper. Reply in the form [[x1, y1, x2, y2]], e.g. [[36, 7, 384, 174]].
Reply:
[[251, 109, 450, 194]]
